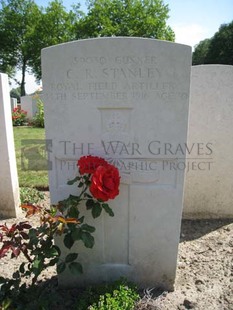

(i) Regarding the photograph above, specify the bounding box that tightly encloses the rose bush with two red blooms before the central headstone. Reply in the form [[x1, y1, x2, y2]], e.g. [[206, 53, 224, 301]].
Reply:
[[0, 156, 120, 308]]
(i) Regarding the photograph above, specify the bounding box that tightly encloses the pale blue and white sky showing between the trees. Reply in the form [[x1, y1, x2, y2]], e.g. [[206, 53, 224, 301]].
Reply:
[[12, 0, 233, 93]]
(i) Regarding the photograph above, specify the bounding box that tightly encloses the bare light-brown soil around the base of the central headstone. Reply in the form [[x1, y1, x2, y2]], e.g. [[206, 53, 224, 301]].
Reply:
[[0, 192, 233, 310]]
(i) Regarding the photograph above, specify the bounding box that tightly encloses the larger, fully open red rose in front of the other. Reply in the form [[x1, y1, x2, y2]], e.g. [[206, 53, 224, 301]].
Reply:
[[90, 164, 120, 201]]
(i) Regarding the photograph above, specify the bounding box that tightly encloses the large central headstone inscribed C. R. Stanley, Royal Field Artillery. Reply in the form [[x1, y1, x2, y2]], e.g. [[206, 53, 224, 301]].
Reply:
[[42, 38, 191, 289]]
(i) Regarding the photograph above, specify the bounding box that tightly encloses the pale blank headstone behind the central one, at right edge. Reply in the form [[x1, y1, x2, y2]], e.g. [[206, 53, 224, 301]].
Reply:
[[184, 65, 233, 218]]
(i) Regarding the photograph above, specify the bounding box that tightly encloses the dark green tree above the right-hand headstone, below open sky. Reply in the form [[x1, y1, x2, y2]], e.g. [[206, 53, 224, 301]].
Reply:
[[193, 21, 233, 65]]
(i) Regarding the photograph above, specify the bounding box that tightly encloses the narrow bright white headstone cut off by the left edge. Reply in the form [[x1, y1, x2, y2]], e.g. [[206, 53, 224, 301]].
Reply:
[[0, 73, 21, 218]]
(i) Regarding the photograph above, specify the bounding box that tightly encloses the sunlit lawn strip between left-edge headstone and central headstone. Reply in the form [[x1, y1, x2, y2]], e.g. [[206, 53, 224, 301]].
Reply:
[[14, 127, 48, 189]]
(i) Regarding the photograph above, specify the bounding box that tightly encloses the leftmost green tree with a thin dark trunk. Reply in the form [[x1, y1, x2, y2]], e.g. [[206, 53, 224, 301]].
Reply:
[[0, 0, 40, 95]]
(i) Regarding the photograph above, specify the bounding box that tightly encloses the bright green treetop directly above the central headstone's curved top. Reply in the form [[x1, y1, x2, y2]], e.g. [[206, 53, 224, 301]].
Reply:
[[76, 0, 175, 41]]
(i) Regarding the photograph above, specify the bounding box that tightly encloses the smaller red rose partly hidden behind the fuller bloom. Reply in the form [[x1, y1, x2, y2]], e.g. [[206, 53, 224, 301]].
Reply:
[[77, 155, 108, 174]]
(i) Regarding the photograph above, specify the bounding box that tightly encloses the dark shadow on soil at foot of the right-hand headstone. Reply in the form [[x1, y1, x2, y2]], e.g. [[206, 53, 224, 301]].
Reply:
[[180, 218, 233, 242]]
